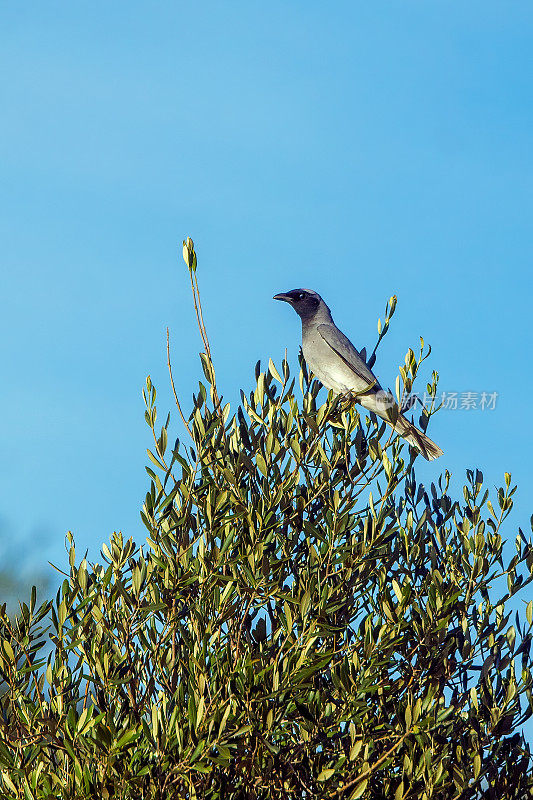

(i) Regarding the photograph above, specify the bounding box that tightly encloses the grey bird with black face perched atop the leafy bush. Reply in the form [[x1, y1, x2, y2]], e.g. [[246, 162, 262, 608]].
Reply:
[[273, 289, 443, 461]]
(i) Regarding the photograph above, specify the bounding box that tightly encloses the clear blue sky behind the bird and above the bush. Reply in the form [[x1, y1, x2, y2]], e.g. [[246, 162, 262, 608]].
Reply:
[[0, 0, 533, 732]]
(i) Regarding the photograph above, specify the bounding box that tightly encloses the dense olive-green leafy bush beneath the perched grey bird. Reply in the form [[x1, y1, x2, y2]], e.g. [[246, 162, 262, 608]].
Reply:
[[0, 240, 533, 800]]
